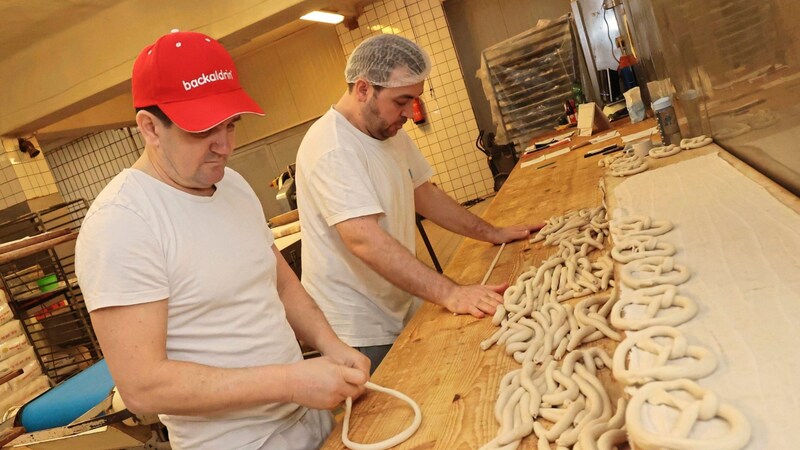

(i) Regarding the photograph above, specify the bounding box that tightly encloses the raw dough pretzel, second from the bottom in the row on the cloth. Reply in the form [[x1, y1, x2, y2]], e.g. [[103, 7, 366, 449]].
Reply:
[[613, 326, 717, 385]]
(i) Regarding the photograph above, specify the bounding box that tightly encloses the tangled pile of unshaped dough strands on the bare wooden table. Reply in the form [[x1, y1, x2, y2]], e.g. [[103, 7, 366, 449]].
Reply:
[[481, 207, 627, 450]]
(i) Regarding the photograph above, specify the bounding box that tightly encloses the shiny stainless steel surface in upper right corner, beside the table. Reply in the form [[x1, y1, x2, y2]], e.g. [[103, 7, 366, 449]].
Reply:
[[625, 0, 800, 194]]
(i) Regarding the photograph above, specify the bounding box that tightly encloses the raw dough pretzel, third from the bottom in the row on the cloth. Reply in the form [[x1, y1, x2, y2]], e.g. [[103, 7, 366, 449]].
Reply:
[[610, 284, 697, 330]]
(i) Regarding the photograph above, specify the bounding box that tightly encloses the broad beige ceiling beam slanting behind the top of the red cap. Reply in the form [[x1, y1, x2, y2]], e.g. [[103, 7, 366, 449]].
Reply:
[[0, 0, 319, 135]]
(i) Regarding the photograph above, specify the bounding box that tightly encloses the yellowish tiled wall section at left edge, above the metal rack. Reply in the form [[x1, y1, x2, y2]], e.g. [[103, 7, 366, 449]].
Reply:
[[0, 138, 58, 209]]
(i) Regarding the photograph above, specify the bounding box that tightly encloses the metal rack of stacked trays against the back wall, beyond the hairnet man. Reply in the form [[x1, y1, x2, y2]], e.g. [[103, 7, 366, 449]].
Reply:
[[481, 15, 580, 148]]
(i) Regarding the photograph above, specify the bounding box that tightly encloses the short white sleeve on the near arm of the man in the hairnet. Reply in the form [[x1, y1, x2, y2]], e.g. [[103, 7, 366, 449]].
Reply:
[[306, 148, 385, 226]]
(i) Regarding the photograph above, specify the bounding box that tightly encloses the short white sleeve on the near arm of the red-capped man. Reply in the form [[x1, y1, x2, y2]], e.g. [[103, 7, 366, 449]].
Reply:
[[75, 205, 169, 311]]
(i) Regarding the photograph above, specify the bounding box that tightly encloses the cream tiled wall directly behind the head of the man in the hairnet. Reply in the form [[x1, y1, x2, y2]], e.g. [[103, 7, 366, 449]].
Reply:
[[337, 0, 494, 202]]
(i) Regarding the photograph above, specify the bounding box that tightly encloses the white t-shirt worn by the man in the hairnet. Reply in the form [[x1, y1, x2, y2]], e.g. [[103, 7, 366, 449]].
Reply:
[[295, 108, 433, 347]]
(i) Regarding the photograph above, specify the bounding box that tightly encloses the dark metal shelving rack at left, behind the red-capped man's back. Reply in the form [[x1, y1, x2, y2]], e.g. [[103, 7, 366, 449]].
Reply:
[[0, 199, 102, 382]]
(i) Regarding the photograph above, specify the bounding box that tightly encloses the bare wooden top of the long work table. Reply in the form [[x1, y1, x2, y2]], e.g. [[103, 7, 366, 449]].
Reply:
[[323, 119, 800, 449]]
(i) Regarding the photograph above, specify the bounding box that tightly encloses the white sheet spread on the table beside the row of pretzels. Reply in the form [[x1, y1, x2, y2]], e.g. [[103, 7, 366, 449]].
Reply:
[[614, 154, 800, 449]]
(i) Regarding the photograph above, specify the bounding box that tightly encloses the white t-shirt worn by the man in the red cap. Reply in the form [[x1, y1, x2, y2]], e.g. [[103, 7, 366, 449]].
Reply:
[[75, 169, 305, 449]]
